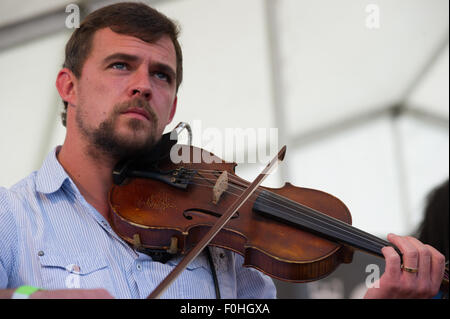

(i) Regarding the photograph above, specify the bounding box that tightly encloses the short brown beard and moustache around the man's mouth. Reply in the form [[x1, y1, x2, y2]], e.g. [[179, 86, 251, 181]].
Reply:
[[76, 98, 160, 161]]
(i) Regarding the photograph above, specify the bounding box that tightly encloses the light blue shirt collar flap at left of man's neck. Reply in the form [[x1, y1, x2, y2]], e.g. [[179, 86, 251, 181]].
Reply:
[[36, 146, 69, 194]]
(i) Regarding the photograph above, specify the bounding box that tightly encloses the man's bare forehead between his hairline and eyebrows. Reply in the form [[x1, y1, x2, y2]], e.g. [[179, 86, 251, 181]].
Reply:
[[91, 28, 176, 67]]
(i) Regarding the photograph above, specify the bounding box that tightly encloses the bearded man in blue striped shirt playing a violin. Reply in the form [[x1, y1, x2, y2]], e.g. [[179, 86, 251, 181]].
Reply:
[[0, 3, 445, 298]]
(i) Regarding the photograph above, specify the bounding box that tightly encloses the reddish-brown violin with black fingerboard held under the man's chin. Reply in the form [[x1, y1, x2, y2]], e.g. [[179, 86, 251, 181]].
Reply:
[[109, 123, 448, 300]]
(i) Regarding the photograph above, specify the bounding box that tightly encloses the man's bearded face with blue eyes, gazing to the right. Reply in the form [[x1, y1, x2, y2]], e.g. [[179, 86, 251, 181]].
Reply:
[[71, 28, 176, 160]]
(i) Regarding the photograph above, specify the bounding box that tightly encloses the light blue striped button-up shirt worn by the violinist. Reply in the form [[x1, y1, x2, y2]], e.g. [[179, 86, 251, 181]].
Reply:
[[0, 148, 276, 299]]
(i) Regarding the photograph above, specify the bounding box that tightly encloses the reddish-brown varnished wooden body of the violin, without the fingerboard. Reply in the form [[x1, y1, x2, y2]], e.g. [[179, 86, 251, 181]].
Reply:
[[109, 145, 353, 282]]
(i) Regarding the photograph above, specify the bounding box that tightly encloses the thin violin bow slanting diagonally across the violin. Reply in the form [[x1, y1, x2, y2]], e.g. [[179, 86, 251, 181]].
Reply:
[[147, 145, 286, 299]]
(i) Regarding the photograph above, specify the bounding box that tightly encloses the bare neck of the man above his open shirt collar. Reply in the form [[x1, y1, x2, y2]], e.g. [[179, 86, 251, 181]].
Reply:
[[57, 140, 115, 221]]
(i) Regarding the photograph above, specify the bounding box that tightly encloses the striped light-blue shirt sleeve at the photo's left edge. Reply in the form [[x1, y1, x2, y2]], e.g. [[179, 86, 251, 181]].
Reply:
[[0, 187, 17, 289]]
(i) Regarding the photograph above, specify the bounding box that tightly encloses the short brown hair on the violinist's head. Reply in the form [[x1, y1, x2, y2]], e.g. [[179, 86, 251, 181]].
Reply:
[[61, 2, 183, 126]]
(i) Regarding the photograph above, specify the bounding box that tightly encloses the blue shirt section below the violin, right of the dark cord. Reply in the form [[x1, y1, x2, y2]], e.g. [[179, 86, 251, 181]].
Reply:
[[235, 254, 277, 299]]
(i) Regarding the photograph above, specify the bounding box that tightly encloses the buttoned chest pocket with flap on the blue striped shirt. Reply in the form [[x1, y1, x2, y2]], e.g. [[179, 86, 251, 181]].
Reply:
[[38, 249, 111, 290]]
